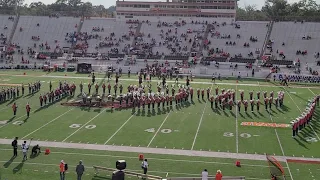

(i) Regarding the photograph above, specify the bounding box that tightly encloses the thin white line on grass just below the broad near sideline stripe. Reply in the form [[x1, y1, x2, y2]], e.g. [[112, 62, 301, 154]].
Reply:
[[0, 149, 276, 168]]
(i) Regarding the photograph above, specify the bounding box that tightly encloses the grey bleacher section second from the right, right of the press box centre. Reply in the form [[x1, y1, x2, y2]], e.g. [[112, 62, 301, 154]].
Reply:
[[203, 21, 268, 58]]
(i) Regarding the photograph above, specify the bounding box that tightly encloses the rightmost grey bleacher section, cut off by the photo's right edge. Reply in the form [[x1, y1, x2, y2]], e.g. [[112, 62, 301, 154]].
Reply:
[[266, 22, 320, 62]]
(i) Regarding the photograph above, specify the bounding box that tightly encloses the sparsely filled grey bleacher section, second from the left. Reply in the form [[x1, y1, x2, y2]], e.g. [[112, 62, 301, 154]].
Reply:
[[12, 16, 80, 52]]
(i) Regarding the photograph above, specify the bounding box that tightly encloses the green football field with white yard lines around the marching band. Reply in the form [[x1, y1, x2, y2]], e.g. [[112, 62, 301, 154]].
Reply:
[[0, 71, 320, 179]]
